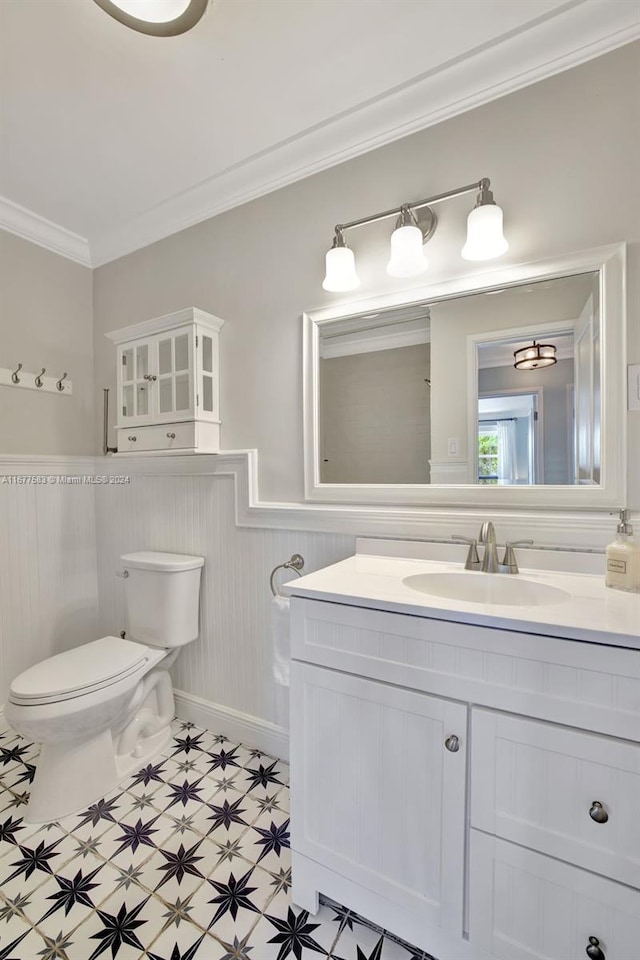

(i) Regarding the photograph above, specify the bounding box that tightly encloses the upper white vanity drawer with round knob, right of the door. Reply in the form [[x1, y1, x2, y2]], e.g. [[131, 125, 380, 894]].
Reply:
[[471, 709, 640, 888]]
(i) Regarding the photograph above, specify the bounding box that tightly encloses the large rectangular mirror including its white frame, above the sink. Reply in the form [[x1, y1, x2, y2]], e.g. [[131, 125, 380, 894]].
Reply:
[[304, 245, 626, 509]]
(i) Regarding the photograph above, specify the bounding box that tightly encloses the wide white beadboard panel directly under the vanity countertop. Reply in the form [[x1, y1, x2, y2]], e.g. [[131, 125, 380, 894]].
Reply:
[[291, 597, 640, 741]]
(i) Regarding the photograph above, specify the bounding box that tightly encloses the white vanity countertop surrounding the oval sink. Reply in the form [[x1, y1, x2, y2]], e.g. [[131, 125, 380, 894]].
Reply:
[[287, 551, 640, 650]]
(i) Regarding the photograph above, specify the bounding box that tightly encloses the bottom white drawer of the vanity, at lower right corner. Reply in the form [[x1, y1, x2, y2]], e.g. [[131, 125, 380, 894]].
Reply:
[[469, 830, 640, 960]]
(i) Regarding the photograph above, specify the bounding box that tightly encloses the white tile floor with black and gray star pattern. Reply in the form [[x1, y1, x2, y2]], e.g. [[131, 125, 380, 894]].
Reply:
[[0, 720, 428, 960]]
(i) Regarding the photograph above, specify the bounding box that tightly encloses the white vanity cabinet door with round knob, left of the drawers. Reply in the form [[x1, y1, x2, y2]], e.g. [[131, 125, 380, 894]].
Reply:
[[291, 661, 467, 932]]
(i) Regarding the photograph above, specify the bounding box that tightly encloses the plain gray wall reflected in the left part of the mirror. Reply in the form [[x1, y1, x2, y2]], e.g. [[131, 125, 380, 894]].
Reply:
[[320, 343, 431, 483]]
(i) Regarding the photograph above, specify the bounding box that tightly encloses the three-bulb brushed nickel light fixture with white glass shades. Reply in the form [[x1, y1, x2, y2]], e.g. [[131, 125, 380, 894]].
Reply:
[[322, 177, 509, 293]]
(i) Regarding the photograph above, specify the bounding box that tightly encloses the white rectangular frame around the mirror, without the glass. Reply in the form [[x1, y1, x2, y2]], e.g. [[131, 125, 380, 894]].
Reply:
[[302, 243, 627, 510]]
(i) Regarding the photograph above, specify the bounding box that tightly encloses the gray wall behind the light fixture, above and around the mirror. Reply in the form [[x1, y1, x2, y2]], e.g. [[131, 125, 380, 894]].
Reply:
[[94, 44, 640, 509]]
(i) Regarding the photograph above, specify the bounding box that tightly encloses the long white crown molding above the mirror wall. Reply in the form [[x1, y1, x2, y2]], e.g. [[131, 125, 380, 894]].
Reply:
[[91, 0, 640, 266]]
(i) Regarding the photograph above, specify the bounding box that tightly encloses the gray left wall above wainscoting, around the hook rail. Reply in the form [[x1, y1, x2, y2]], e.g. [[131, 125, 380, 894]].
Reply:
[[0, 230, 95, 454]]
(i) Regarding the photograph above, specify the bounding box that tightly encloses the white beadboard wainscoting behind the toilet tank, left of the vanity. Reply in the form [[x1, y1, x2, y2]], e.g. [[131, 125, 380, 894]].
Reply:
[[96, 472, 355, 722]]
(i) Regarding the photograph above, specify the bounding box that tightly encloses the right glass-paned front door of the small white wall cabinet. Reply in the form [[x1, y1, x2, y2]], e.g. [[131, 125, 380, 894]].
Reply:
[[154, 327, 196, 423]]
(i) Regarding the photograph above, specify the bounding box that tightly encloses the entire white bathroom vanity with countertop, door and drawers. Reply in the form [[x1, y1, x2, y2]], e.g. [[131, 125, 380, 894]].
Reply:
[[290, 541, 640, 960]]
